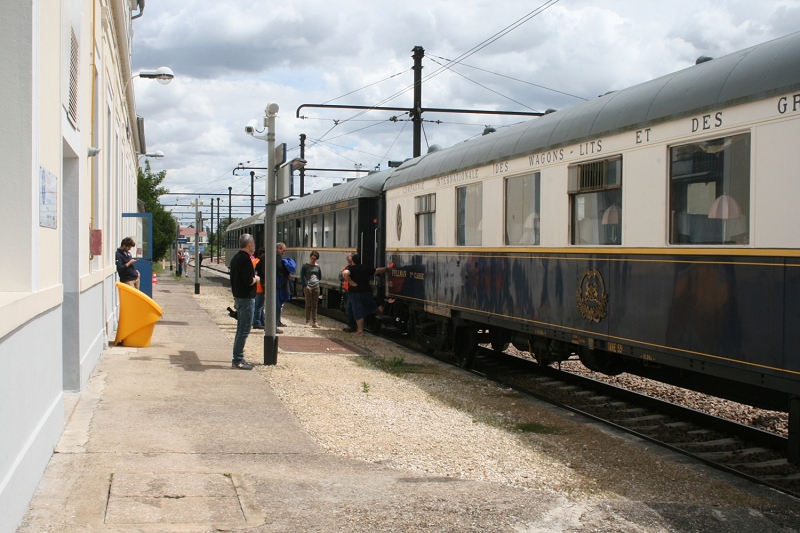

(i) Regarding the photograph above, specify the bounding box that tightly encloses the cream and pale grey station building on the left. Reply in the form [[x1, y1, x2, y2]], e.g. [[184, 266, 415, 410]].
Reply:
[[0, 0, 155, 533]]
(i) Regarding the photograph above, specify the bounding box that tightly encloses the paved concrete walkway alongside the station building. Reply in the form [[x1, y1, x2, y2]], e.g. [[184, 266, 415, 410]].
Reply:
[[19, 281, 800, 533]]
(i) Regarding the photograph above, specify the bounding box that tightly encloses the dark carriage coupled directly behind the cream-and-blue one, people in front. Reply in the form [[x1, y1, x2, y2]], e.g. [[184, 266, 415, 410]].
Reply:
[[277, 171, 390, 309]]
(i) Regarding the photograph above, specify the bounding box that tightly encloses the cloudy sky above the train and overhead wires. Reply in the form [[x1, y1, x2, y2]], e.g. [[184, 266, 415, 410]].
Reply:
[[133, 0, 800, 223]]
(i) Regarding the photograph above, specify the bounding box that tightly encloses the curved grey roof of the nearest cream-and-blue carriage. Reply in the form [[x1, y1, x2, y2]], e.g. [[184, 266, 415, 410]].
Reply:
[[385, 32, 800, 189]]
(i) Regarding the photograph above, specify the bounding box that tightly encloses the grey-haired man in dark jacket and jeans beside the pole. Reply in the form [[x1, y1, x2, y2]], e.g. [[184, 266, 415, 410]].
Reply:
[[231, 233, 260, 370]]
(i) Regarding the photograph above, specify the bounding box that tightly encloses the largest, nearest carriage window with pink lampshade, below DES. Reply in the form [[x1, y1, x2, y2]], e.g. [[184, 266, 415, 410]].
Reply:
[[669, 133, 750, 245]]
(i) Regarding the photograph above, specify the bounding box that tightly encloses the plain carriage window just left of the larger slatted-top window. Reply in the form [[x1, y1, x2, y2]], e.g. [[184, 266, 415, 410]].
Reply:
[[506, 172, 541, 246]]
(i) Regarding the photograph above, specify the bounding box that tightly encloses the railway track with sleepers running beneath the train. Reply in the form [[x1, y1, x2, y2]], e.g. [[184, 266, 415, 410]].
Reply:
[[195, 266, 800, 497]]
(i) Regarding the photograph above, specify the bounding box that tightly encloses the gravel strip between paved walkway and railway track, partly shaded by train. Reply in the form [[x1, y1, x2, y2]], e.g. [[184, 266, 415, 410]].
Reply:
[[186, 280, 788, 507]]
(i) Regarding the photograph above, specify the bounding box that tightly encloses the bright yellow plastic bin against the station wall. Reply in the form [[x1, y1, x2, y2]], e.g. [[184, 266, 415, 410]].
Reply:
[[114, 281, 164, 348]]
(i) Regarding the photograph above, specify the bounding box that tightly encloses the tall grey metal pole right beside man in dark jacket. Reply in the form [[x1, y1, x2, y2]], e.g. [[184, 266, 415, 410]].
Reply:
[[263, 103, 279, 365]]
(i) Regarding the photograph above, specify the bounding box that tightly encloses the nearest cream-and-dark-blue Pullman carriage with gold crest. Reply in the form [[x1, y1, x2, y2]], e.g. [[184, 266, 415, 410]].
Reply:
[[385, 33, 800, 459]]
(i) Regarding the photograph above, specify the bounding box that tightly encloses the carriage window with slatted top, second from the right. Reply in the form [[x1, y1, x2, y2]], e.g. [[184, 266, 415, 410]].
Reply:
[[569, 157, 622, 245]]
